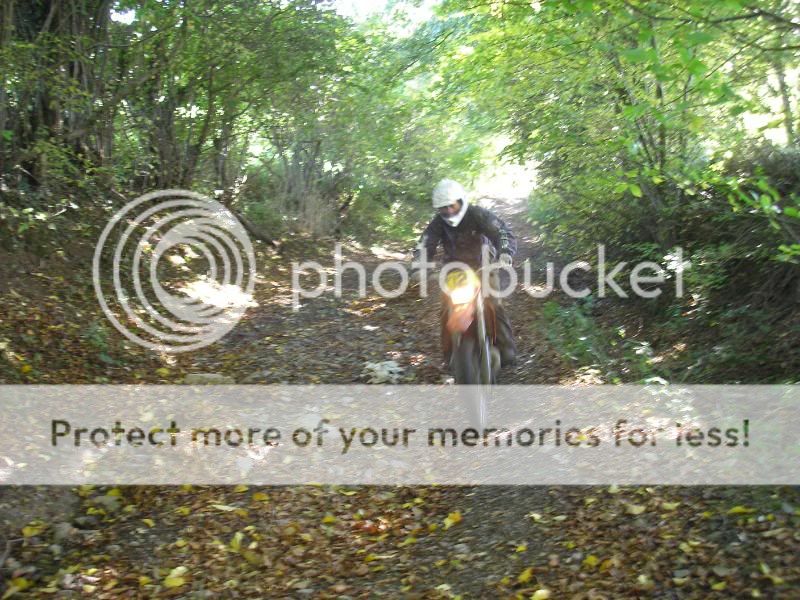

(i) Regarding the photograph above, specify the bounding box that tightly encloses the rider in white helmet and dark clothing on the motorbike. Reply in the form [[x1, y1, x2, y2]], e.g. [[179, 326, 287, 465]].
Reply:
[[414, 179, 517, 366]]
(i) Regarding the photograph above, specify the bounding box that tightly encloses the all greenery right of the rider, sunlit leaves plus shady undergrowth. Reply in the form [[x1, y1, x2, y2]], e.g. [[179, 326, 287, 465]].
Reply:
[[432, 0, 800, 381]]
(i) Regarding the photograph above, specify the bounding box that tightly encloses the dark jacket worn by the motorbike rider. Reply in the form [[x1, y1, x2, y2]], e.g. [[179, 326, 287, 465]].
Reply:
[[414, 204, 517, 268]]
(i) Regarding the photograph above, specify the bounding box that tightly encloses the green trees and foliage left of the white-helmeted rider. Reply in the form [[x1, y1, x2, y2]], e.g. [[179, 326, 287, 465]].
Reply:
[[0, 0, 484, 245]]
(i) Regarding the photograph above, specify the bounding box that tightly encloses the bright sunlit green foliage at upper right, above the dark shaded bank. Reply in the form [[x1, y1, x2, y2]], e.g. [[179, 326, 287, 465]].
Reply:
[[442, 1, 798, 259]]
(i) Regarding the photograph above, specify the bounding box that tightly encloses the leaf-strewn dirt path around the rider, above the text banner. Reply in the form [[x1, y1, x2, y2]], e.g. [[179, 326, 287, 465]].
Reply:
[[173, 199, 570, 384]]
